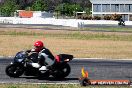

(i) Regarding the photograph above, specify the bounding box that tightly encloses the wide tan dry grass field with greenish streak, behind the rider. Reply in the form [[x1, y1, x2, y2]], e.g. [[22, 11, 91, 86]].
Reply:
[[0, 28, 132, 59]]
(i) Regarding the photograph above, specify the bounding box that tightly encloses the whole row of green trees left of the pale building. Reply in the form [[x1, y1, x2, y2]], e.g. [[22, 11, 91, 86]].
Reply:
[[0, 0, 91, 16]]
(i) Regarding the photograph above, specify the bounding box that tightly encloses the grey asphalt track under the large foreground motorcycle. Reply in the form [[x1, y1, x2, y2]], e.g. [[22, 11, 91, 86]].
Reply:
[[0, 58, 132, 83]]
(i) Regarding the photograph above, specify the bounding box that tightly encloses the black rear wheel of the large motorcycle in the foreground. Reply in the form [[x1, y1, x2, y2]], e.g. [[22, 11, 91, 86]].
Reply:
[[52, 64, 71, 78]]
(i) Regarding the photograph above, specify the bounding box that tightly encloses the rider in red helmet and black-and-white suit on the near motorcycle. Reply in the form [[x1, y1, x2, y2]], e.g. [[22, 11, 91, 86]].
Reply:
[[27, 41, 55, 70]]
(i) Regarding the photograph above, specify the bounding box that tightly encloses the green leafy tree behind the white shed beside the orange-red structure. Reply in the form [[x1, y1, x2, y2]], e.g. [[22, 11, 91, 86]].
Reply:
[[31, 0, 47, 11]]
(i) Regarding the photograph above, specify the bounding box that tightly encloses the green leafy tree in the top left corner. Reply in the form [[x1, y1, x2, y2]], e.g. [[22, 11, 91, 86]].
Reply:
[[0, 0, 19, 16]]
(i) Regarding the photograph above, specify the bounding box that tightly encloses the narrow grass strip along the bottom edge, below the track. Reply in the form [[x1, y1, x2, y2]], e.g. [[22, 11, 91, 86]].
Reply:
[[0, 84, 132, 88]]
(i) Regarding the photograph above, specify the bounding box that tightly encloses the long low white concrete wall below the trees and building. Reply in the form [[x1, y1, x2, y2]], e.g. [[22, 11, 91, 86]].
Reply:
[[0, 17, 132, 27]]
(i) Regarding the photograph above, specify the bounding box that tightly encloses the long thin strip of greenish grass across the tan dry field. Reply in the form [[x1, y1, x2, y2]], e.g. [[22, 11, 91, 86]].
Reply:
[[0, 29, 132, 41]]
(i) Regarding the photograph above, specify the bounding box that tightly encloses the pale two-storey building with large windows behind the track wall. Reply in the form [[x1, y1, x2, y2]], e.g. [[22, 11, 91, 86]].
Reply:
[[90, 0, 132, 21]]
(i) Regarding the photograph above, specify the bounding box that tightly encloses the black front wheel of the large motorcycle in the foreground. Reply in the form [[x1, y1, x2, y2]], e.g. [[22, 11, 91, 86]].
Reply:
[[5, 64, 24, 78]]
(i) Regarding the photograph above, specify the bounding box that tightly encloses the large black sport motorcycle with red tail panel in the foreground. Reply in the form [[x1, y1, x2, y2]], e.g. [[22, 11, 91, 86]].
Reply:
[[5, 51, 73, 78]]
